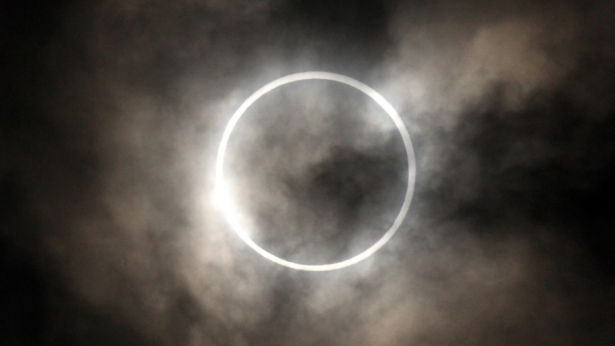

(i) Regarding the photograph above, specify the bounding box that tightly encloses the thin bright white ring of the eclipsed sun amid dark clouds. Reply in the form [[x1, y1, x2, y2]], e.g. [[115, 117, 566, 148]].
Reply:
[[215, 72, 416, 271]]
